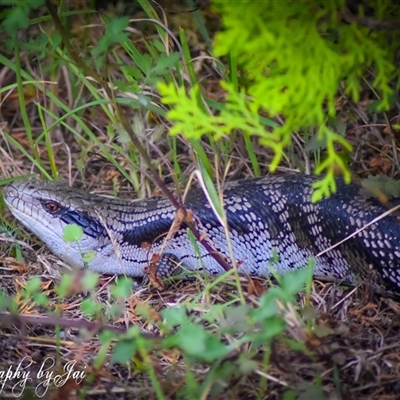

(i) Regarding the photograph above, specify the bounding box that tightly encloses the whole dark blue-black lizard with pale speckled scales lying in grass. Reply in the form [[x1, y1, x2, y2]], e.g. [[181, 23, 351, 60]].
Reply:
[[4, 174, 400, 293]]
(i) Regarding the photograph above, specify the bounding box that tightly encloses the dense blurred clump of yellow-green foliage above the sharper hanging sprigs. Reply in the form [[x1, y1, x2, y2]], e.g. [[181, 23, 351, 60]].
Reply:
[[215, 1, 398, 111]]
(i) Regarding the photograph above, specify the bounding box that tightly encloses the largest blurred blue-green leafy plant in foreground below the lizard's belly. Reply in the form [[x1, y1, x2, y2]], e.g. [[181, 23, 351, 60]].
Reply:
[[100, 262, 316, 398]]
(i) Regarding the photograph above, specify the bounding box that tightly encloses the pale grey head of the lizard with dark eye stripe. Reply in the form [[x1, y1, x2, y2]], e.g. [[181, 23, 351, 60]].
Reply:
[[3, 180, 107, 268]]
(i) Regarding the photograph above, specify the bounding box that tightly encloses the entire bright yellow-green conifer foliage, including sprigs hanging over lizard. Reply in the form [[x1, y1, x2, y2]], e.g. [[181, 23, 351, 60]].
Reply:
[[160, 0, 400, 200]]
